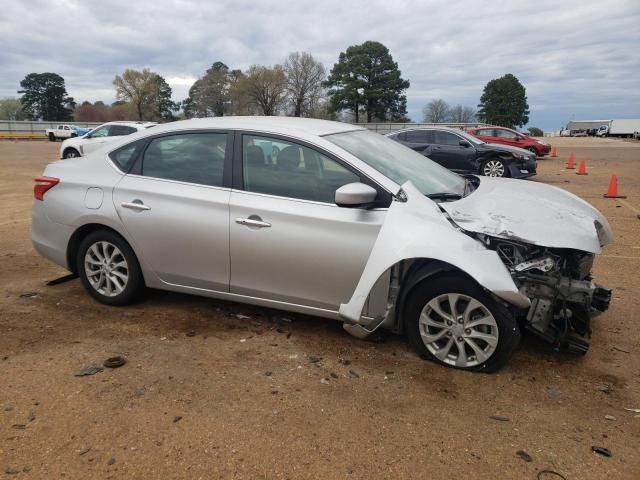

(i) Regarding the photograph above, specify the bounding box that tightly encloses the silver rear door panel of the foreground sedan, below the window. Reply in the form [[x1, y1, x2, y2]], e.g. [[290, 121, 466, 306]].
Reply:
[[114, 175, 230, 291]]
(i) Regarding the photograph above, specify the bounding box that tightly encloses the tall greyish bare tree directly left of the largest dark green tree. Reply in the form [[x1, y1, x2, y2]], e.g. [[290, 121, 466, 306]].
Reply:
[[283, 52, 326, 117]]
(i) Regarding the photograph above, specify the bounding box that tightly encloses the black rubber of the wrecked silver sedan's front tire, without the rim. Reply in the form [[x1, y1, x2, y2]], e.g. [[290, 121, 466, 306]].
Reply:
[[404, 273, 520, 373]]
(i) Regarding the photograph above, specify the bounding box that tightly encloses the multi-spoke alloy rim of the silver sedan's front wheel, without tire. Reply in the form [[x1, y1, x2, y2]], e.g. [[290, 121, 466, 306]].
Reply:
[[418, 293, 498, 368]]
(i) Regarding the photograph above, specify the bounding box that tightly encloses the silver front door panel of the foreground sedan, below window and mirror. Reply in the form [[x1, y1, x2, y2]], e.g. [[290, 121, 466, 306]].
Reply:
[[230, 190, 386, 310]]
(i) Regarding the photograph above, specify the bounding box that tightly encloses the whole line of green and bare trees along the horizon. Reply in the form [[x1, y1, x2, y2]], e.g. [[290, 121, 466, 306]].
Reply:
[[0, 41, 529, 126]]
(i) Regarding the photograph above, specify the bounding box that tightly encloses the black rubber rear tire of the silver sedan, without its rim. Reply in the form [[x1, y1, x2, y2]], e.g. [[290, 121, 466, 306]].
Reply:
[[76, 230, 145, 306]]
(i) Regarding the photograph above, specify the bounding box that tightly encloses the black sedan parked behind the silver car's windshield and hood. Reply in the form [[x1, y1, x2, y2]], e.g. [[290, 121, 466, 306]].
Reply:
[[387, 127, 537, 178]]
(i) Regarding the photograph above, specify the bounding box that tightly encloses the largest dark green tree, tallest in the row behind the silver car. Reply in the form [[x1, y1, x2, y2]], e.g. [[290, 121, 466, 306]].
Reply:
[[325, 41, 409, 122]]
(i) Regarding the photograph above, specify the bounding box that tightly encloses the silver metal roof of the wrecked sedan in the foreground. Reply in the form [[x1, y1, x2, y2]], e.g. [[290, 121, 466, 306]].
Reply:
[[146, 116, 365, 136]]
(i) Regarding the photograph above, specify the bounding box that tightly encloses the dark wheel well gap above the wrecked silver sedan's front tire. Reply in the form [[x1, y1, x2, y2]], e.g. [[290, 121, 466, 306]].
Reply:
[[392, 258, 477, 332]]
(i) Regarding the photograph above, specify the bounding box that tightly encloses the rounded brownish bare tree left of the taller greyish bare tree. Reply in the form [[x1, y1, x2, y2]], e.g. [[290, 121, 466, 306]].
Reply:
[[242, 65, 287, 115]]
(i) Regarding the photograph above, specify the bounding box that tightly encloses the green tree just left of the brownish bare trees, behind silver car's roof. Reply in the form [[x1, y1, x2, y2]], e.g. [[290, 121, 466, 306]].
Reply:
[[183, 62, 232, 117]]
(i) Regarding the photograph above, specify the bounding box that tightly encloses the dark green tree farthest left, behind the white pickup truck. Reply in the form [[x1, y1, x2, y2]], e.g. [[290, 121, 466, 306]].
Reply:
[[18, 72, 75, 121]]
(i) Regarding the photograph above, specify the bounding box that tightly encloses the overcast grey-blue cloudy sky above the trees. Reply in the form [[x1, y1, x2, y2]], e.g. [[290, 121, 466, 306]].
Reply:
[[0, 0, 640, 129]]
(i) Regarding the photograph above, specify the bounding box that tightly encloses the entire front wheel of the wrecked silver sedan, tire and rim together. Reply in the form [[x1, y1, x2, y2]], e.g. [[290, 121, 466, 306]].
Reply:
[[405, 273, 520, 373]]
